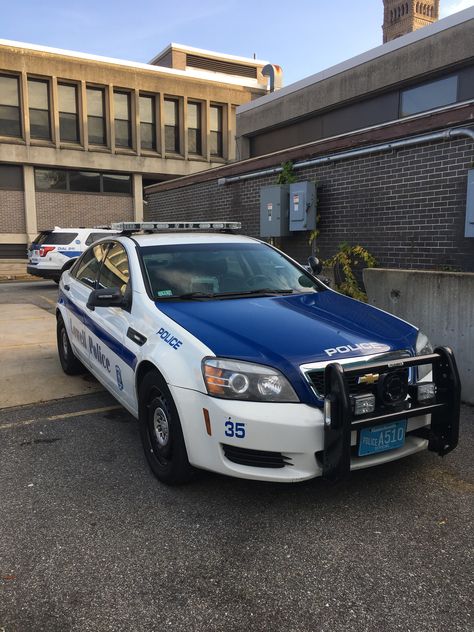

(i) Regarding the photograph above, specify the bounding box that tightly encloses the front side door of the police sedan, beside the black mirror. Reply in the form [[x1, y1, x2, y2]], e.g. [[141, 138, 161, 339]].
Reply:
[[90, 241, 136, 402]]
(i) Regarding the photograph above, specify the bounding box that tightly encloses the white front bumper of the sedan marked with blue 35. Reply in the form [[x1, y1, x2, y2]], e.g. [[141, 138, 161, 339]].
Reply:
[[170, 386, 436, 483]]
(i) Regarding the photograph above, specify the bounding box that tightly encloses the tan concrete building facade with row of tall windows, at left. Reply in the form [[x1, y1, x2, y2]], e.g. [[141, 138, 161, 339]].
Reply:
[[0, 41, 266, 258]]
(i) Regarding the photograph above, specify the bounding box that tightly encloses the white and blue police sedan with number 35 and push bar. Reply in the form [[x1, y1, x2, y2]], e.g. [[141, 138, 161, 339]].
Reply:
[[57, 222, 460, 484]]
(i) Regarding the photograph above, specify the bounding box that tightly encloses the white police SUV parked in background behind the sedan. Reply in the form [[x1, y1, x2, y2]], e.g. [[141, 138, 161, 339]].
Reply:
[[26, 226, 117, 282]]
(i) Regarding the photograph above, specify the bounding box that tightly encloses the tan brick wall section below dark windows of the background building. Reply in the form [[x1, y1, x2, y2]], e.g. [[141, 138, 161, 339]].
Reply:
[[36, 191, 133, 230]]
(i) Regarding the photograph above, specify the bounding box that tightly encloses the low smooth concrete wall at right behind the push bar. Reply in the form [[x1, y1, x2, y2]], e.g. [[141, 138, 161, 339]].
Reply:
[[364, 268, 474, 404]]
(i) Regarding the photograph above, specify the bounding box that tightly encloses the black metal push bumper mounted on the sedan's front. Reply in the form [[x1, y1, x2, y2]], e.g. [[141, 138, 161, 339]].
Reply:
[[321, 347, 461, 481]]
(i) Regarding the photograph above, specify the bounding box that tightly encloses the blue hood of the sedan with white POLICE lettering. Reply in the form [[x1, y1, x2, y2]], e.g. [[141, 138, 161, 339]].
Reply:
[[156, 290, 418, 382]]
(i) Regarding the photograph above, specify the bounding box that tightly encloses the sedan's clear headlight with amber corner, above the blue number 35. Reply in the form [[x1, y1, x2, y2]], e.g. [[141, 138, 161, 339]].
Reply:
[[202, 358, 299, 402]]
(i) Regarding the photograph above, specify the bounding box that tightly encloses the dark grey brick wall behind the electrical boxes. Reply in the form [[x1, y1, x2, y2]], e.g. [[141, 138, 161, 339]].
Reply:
[[146, 139, 474, 272]]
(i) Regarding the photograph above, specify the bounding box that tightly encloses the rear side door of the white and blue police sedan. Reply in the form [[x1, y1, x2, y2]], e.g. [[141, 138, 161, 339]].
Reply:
[[59, 243, 108, 366]]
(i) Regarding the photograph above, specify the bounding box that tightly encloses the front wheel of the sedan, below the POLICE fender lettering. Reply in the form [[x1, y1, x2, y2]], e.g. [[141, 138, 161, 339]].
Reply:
[[138, 371, 194, 485]]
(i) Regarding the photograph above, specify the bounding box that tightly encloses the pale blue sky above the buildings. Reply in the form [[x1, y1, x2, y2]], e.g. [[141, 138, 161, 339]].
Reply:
[[0, 0, 474, 85]]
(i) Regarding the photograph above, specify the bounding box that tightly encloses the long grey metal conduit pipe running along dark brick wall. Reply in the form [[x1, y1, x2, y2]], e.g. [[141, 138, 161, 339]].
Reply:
[[217, 127, 474, 185]]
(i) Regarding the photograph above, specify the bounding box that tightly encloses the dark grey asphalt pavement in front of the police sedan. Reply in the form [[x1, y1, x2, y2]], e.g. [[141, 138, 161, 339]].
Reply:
[[0, 393, 474, 632]]
